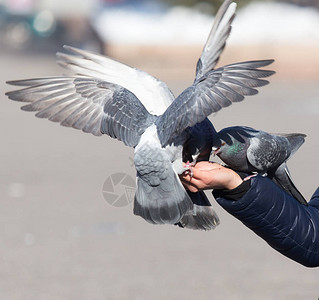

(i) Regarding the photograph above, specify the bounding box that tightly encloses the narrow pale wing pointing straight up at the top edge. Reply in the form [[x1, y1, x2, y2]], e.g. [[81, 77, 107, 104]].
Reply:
[[195, 0, 237, 81]]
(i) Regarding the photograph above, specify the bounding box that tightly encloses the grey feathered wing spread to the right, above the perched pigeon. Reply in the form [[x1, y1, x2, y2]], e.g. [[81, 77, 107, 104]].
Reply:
[[156, 60, 275, 146]]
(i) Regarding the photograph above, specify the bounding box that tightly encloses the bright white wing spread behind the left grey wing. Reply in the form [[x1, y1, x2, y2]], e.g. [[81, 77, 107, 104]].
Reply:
[[57, 46, 175, 115]]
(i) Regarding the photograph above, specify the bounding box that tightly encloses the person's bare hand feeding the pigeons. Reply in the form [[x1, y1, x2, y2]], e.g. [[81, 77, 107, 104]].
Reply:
[[180, 161, 243, 192]]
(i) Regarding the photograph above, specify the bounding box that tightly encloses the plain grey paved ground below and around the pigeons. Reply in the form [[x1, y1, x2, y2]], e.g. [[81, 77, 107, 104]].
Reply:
[[0, 48, 319, 300]]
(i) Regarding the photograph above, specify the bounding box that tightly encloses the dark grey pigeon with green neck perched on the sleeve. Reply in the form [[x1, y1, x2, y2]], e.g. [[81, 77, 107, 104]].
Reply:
[[212, 126, 307, 205]]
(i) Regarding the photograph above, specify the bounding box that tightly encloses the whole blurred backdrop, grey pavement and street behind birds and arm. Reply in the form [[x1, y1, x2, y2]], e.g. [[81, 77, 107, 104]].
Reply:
[[0, 0, 319, 300]]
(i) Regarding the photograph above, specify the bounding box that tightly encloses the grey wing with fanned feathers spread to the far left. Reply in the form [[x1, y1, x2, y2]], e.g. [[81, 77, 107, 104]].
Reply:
[[6, 77, 155, 147]]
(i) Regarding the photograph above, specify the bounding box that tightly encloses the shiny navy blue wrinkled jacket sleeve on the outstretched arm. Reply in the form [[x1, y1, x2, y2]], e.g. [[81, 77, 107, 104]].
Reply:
[[213, 176, 319, 267]]
